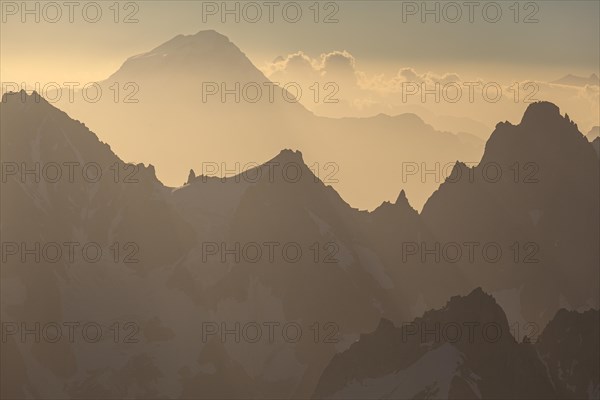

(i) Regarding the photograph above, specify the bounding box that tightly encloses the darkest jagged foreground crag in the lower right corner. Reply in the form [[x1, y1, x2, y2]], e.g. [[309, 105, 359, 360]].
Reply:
[[314, 289, 600, 399]]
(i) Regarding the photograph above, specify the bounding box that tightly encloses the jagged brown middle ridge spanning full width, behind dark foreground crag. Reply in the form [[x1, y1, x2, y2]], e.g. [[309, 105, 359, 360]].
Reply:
[[0, 93, 599, 398]]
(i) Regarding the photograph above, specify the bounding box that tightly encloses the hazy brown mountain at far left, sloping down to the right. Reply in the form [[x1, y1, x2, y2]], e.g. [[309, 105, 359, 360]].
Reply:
[[0, 92, 192, 398]]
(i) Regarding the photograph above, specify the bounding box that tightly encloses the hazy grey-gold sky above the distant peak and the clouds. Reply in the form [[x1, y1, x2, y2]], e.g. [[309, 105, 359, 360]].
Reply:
[[0, 0, 600, 82]]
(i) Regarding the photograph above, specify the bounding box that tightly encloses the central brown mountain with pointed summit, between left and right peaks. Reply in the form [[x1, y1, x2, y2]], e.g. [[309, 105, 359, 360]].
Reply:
[[166, 150, 426, 398]]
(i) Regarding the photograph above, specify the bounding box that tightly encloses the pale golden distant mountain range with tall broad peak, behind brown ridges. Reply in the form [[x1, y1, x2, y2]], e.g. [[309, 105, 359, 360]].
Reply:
[[48, 30, 484, 210]]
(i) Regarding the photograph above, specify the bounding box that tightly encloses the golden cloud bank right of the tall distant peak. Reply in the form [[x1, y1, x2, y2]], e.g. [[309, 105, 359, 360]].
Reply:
[[263, 50, 600, 133]]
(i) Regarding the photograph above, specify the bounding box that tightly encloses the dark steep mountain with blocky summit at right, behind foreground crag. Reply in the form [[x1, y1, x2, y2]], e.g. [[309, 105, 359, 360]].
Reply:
[[421, 102, 600, 324]]
